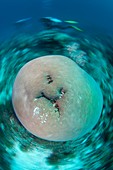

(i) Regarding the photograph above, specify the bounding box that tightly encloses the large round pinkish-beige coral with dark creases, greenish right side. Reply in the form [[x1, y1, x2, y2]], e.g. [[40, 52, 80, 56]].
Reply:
[[12, 55, 103, 141]]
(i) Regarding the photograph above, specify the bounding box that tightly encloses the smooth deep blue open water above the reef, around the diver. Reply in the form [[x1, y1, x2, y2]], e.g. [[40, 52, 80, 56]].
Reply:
[[0, 0, 113, 38]]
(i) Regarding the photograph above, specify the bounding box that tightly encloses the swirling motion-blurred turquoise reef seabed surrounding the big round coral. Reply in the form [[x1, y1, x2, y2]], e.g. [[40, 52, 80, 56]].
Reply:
[[0, 25, 113, 170]]
